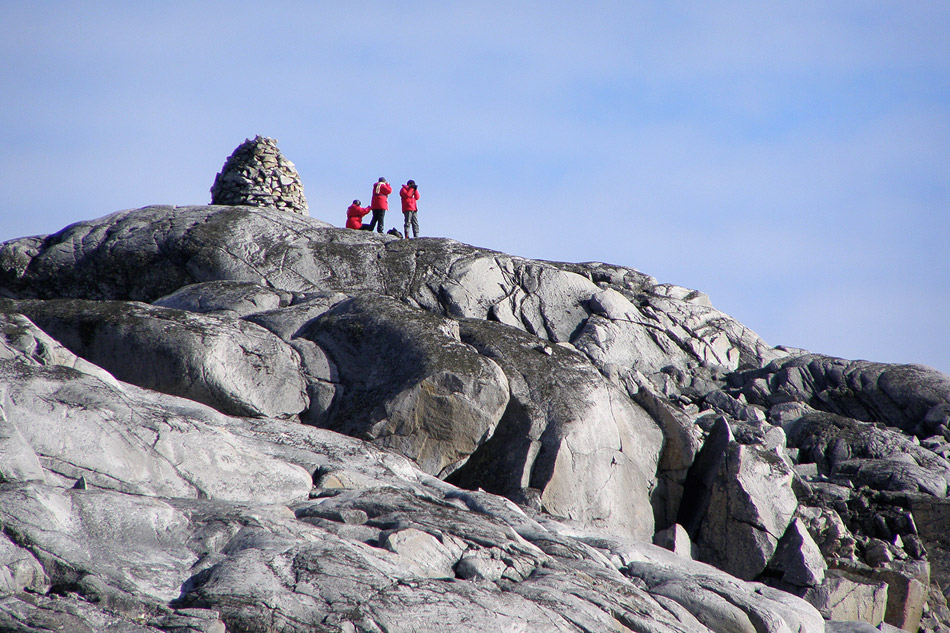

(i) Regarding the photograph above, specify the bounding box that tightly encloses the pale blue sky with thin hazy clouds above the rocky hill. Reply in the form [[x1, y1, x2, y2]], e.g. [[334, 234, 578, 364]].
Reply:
[[0, 0, 950, 373]]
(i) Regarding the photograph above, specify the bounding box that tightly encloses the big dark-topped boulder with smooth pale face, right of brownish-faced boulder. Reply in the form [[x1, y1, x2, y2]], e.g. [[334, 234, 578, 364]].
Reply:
[[451, 320, 663, 539]]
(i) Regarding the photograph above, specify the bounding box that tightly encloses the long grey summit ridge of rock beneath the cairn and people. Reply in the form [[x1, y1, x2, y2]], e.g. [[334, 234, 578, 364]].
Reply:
[[0, 206, 787, 388]]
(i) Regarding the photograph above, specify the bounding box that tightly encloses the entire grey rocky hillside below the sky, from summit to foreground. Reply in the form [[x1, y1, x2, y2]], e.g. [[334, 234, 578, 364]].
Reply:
[[0, 204, 950, 633]]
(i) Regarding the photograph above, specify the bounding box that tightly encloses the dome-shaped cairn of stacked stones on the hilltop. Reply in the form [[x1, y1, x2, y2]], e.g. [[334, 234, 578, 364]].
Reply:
[[211, 135, 309, 215]]
